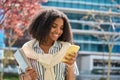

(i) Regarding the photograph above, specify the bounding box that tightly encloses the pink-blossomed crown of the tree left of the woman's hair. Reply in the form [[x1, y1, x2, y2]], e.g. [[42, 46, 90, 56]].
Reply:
[[0, 0, 47, 80]]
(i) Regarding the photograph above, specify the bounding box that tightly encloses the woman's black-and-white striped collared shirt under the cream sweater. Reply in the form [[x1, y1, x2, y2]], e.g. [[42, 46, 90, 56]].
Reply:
[[19, 41, 78, 80]]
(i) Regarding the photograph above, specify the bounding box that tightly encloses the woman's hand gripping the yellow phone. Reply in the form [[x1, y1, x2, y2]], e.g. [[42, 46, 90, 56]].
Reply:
[[63, 53, 78, 66]]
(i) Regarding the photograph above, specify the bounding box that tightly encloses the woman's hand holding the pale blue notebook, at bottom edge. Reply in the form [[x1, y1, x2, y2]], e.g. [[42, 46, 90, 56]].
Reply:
[[22, 67, 37, 80]]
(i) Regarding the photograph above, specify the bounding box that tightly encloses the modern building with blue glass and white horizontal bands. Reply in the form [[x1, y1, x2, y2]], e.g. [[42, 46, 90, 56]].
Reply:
[[42, 0, 120, 80]]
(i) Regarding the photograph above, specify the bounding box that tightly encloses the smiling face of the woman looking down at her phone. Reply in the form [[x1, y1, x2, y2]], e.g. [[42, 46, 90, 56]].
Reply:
[[48, 18, 64, 42]]
